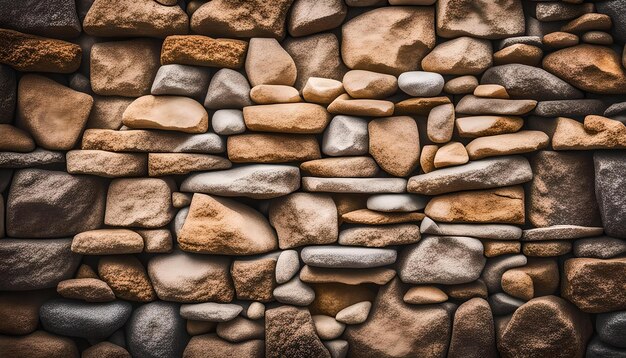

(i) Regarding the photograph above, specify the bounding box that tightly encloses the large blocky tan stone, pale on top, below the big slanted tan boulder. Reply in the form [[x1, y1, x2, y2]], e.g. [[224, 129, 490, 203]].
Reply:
[[144, 250, 235, 304]]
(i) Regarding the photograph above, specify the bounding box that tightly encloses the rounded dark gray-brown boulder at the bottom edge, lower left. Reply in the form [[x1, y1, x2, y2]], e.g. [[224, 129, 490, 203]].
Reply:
[[126, 301, 189, 358]]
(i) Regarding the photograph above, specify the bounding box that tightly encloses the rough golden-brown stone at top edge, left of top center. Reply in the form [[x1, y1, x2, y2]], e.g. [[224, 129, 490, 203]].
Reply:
[[191, 0, 293, 39]]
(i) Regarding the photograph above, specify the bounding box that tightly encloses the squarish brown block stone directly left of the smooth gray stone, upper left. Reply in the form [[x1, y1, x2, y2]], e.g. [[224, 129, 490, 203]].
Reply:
[[90, 39, 161, 97]]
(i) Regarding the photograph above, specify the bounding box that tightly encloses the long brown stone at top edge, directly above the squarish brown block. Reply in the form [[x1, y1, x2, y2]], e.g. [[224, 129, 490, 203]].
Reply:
[[83, 0, 189, 37]]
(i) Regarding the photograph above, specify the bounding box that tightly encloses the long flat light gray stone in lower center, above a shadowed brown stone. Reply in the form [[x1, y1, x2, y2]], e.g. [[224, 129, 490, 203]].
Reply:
[[300, 246, 397, 268]]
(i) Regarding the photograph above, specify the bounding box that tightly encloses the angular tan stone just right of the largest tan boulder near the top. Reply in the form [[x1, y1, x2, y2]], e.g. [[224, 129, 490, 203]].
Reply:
[[422, 36, 492, 75]]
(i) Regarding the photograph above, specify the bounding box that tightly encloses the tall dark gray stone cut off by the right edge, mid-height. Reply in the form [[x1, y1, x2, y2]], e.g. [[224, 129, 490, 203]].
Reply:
[[593, 151, 626, 239]]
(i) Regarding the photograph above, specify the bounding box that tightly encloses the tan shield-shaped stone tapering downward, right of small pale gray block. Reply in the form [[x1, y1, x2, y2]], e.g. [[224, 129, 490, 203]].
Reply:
[[367, 116, 420, 176]]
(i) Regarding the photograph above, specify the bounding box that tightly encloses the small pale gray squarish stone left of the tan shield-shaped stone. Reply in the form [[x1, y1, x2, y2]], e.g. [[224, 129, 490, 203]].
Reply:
[[322, 115, 369, 156]]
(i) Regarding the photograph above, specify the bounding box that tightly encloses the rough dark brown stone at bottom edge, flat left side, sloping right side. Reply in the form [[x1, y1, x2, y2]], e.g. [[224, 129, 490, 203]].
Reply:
[[265, 306, 330, 358]]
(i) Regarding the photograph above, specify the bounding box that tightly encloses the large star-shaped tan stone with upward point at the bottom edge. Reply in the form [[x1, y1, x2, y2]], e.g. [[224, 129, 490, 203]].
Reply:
[[344, 280, 451, 357]]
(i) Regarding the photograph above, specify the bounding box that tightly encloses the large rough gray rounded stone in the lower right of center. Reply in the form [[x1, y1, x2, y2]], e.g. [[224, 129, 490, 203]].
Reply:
[[398, 236, 486, 285]]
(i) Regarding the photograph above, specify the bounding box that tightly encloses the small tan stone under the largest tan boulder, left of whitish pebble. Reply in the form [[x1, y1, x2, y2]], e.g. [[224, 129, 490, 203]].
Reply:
[[343, 70, 398, 99]]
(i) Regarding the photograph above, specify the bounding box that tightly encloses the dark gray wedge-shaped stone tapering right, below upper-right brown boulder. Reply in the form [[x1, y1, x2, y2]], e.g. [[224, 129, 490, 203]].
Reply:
[[480, 63, 583, 101]]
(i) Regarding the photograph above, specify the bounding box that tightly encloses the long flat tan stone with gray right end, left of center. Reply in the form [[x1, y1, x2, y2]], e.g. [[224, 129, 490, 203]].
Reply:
[[82, 129, 226, 153]]
